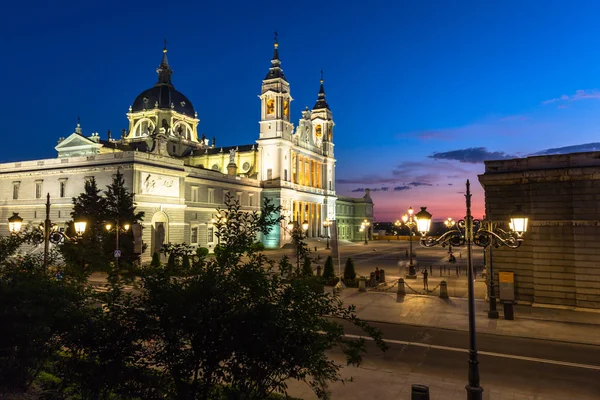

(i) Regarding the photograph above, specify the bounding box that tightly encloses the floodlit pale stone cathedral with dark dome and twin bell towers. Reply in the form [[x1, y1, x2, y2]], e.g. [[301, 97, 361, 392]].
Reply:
[[0, 40, 373, 261]]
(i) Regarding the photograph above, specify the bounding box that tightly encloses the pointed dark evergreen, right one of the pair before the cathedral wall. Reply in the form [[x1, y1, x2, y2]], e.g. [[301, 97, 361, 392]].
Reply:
[[104, 170, 144, 270]]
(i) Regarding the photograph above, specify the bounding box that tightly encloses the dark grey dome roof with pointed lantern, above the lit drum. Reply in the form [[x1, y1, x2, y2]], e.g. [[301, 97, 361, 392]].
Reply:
[[131, 41, 196, 118]]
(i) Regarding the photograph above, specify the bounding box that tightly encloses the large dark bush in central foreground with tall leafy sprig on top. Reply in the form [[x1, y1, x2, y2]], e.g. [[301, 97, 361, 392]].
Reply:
[[131, 196, 385, 399]]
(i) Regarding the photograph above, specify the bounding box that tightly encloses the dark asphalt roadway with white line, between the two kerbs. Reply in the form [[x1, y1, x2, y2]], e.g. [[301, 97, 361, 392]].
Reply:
[[326, 323, 600, 399]]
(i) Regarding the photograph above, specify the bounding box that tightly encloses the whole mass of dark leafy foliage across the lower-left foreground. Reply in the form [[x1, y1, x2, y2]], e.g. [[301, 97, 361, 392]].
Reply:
[[0, 195, 385, 399]]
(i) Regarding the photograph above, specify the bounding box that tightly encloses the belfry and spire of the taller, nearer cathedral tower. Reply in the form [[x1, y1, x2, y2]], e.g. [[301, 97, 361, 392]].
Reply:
[[259, 32, 293, 140]]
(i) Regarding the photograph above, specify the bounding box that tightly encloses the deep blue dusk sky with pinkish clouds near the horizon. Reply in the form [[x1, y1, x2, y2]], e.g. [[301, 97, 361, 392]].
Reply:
[[0, 0, 600, 221]]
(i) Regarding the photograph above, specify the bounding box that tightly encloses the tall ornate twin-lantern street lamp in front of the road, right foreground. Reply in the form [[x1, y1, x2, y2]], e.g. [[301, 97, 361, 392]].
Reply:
[[417, 180, 527, 400]]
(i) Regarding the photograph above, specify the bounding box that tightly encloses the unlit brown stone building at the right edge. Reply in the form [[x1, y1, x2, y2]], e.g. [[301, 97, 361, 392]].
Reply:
[[479, 152, 600, 309]]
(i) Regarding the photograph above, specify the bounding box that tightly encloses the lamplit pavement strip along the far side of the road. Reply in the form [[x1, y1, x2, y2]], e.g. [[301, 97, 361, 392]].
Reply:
[[340, 277, 600, 346]]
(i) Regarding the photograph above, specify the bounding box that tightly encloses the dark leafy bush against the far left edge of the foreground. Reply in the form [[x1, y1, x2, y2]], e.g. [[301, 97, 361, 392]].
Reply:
[[0, 256, 85, 393]]
